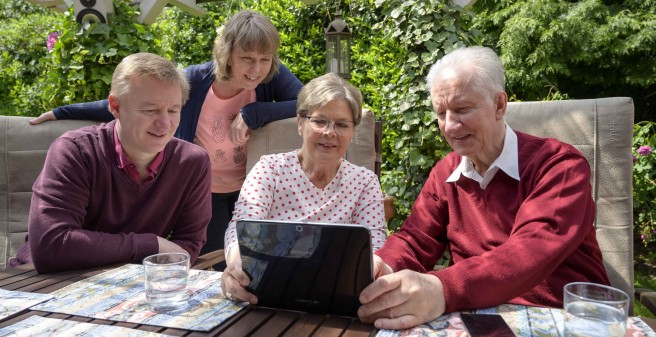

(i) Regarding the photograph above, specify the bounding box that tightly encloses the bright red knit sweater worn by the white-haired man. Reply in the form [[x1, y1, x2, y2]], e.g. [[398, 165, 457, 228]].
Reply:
[[376, 132, 609, 312]]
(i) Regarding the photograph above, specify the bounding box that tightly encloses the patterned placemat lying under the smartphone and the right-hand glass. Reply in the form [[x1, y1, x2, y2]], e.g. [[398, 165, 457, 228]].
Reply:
[[376, 304, 656, 337]]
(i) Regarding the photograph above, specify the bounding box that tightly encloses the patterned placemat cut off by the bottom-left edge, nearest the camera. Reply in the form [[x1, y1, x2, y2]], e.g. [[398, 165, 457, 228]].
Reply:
[[0, 316, 173, 337]]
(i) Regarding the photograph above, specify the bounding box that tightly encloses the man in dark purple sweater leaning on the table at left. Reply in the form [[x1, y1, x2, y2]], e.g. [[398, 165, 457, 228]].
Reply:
[[9, 53, 211, 272]]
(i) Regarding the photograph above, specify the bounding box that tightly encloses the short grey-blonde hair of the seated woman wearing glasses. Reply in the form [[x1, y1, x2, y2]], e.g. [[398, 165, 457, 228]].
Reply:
[[296, 73, 362, 126]]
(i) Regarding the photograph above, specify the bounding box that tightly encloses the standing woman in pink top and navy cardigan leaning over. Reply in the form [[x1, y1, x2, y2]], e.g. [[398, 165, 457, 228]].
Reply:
[[26, 11, 303, 270]]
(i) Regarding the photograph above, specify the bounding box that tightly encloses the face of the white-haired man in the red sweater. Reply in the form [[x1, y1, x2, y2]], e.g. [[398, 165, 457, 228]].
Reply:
[[431, 70, 506, 172]]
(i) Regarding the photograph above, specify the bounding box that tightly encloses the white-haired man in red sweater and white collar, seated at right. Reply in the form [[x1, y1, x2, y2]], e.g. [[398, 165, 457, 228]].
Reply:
[[358, 47, 609, 329]]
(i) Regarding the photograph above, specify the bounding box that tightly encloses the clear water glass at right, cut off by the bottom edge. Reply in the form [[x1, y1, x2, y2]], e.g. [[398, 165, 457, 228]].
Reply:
[[563, 282, 631, 337]]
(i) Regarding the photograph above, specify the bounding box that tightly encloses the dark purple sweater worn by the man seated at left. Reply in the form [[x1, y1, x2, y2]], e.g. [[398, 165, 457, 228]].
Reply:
[[10, 121, 212, 272]]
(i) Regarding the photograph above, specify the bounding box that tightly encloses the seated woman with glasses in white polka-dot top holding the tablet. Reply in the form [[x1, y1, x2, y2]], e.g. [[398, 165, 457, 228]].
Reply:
[[222, 73, 387, 304]]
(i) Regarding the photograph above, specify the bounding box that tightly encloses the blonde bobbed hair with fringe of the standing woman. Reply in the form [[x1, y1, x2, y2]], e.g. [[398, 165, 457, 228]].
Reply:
[[212, 10, 280, 82]]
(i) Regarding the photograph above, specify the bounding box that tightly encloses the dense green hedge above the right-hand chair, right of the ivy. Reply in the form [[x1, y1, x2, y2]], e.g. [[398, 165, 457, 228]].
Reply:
[[474, 0, 656, 121]]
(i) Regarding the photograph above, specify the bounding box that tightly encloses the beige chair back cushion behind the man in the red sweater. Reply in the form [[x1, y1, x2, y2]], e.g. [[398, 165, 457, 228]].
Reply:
[[506, 97, 634, 304]]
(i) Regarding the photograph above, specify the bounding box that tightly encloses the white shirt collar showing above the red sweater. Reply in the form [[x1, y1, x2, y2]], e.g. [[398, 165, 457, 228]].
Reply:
[[446, 123, 519, 189]]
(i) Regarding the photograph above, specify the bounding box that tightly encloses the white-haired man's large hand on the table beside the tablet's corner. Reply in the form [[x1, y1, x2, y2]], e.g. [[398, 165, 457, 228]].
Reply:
[[358, 270, 445, 329]]
